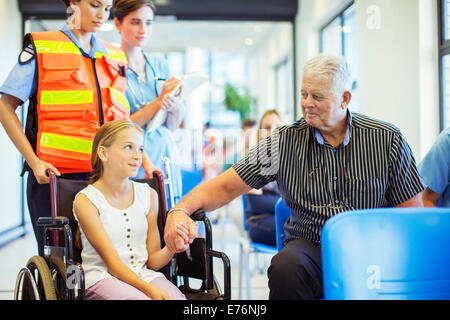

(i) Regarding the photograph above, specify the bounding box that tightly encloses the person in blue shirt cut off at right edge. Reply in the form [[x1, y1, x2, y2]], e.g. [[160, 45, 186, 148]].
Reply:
[[418, 127, 450, 207]]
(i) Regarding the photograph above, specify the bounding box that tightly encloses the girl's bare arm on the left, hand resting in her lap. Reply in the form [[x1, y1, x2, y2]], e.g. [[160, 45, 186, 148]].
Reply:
[[73, 194, 169, 300]]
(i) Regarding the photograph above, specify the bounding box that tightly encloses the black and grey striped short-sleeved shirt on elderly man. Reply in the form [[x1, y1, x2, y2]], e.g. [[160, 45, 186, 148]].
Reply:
[[233, 111, 425, 244]]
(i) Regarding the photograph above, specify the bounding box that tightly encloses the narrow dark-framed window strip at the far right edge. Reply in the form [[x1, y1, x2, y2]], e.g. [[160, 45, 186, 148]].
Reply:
[[439, 0, 450, 131]]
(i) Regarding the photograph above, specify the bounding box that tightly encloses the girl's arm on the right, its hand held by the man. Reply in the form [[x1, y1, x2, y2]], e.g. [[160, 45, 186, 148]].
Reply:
[[147, 189, 185, 270]]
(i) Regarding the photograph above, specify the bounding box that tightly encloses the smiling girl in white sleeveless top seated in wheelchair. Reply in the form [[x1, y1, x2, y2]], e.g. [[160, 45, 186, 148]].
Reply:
[[73, 120, 187, 300]]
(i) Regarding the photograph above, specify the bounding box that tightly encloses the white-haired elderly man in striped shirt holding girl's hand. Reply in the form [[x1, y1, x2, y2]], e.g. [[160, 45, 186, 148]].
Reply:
[[165, 55, 424, 299]]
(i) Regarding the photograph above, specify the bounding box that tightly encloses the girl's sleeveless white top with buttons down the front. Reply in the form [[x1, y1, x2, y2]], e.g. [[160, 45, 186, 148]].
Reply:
[[74, 181, 164, 289]]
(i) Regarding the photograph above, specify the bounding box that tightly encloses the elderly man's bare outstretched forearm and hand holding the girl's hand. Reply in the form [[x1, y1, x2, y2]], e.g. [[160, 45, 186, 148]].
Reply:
[[164, 168, 252, 252]]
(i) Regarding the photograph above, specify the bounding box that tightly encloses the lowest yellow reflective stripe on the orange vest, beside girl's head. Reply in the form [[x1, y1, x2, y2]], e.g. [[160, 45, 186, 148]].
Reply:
[[40, 132, 93, 154]]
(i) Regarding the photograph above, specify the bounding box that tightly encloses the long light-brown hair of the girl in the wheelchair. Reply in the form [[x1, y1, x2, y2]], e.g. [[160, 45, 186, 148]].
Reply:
[[89, 120, 144, 184]]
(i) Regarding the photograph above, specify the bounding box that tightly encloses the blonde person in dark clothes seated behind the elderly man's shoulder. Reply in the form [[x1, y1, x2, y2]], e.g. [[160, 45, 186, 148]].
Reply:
[[244, 109, 281, 247]]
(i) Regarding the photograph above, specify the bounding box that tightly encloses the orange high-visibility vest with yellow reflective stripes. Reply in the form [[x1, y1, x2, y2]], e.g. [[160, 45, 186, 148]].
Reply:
[[31, 31, 130, 173]]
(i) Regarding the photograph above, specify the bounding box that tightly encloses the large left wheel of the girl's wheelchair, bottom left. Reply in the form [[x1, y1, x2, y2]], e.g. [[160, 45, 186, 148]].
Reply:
[[16, 256, 56, 300]]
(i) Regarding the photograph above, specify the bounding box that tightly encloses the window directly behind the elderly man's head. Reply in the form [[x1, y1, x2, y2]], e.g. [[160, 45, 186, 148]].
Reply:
[[320, 0, 358, 111]]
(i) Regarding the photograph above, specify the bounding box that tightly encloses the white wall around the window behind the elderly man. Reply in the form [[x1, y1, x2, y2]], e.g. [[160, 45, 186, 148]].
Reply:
[[296, 0, 439, 161]]
